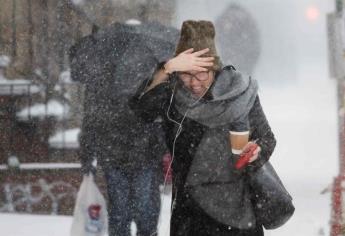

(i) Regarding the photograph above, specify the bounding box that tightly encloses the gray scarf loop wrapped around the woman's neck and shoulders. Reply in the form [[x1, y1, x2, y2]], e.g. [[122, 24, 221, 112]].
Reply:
[[175, 70, 258, 128]]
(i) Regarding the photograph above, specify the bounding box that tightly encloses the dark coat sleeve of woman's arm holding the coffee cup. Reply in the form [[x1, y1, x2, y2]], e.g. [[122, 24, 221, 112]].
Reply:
[[248, 96, 276, 171]]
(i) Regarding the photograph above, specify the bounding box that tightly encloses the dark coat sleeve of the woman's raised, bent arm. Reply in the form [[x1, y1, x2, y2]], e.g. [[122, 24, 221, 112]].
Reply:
[[129, 61, 171, 122]]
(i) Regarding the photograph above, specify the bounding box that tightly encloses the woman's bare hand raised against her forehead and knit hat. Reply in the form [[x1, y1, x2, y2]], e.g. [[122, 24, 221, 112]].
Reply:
[[164, 48, 214, 72]]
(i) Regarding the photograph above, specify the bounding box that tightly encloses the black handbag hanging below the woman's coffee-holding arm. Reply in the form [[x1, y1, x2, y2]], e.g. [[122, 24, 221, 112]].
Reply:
[[248, 162, 295, 229]]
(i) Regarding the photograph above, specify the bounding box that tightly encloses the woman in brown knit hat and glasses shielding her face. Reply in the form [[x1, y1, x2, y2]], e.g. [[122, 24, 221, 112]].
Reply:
[[129, 21, 276, 236]]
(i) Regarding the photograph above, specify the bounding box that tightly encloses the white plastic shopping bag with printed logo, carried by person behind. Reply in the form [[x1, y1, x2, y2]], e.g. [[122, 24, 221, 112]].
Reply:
[[71, 174, 108, 236]]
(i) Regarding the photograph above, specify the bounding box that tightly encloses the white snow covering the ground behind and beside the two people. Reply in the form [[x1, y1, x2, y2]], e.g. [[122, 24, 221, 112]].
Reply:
[[0, 78, 338, 236]]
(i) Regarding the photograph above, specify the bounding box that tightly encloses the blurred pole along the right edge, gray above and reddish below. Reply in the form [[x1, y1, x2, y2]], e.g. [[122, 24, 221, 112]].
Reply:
[[327, 0, 345, 236]]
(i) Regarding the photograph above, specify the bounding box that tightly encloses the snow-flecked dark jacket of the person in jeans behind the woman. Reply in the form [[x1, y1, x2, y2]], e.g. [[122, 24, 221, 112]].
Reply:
[[70, 31, 166, 172]]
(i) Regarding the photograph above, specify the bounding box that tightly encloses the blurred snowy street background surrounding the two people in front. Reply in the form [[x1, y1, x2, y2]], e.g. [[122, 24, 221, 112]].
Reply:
[[0, 0, 345, 236]]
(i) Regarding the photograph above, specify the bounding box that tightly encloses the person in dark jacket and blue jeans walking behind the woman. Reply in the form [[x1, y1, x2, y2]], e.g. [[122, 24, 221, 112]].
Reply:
[[71, 25, 166, 236]]
